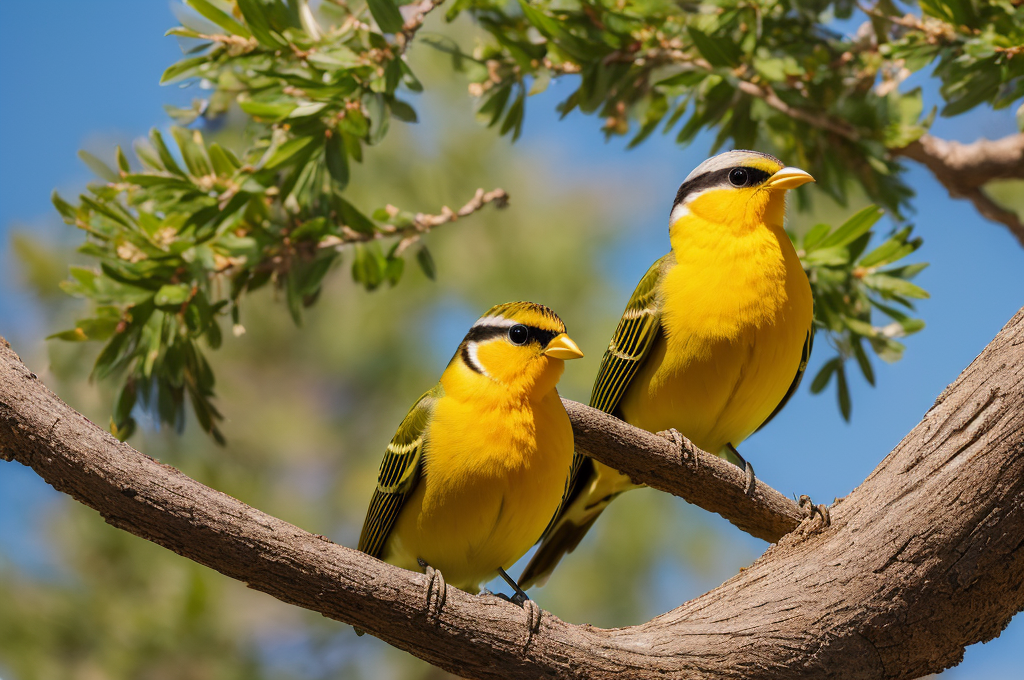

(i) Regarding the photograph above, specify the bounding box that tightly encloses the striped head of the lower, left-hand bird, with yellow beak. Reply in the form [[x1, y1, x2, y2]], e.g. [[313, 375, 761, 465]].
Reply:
[[455, 302, 583, 391]]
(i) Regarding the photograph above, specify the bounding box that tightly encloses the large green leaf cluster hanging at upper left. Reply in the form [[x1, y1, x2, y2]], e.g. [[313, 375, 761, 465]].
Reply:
[[53, 0, 460, 440]]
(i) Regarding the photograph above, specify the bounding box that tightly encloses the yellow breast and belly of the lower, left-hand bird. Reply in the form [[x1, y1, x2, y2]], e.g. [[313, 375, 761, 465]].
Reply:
[[384, 363, 572, 592]]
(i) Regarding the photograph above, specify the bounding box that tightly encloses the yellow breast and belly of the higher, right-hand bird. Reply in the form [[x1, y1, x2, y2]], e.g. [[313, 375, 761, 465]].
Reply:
[[620, 206, 813, 453]]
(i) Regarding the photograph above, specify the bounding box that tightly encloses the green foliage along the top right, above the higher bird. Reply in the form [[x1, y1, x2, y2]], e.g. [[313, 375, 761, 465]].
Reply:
[[448, 0, 1024, 215]]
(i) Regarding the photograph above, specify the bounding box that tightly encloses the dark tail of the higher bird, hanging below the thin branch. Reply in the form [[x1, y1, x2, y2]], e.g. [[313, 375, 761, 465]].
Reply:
[[519, 458, 637, 590]]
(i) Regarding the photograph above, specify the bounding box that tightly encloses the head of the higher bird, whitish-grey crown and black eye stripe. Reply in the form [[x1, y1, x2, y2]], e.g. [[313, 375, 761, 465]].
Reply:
[[669, 151, 814, 235]]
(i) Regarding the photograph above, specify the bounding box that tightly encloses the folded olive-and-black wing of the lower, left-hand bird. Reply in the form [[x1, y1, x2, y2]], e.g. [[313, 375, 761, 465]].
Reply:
[[359, 384, 444, 557]]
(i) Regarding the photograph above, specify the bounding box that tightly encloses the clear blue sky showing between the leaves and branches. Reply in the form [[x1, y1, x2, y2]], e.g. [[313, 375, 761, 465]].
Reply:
[[0, 0, 1024, 680]]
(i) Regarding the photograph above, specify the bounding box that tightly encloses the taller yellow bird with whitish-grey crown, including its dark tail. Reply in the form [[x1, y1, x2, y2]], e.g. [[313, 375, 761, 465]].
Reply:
[[519, 151, 814, 588]]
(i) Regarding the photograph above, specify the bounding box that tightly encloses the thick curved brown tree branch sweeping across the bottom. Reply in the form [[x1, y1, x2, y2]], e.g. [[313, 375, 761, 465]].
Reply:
[[0, 310, 1024, 680]]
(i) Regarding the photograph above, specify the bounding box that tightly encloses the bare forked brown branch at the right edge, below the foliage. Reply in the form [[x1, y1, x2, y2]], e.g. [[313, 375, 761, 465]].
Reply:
[[890, 133, 1024, 246]]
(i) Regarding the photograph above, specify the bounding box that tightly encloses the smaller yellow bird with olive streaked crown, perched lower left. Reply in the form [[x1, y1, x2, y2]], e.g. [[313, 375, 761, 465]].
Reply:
[[359, 302, 583, 597]]
